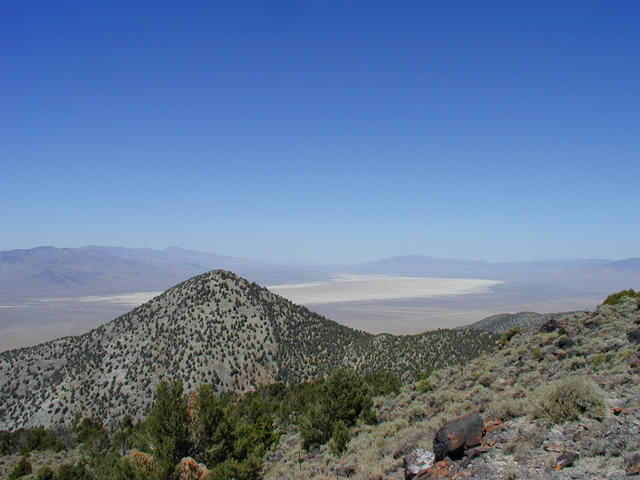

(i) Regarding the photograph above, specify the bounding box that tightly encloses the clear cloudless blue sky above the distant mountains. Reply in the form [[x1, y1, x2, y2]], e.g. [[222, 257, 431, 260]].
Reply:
[[0, 0, 640, 261]]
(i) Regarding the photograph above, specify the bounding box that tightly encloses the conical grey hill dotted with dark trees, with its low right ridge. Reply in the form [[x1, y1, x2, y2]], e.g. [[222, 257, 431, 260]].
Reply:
[[0, 270, 495, 430]]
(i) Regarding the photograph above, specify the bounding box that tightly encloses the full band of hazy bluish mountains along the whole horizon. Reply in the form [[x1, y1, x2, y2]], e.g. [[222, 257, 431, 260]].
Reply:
[[0, 246, 640, 299]]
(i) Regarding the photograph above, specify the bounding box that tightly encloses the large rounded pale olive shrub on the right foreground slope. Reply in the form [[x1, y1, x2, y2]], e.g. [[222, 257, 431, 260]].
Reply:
[[533, 375, 604, 423]]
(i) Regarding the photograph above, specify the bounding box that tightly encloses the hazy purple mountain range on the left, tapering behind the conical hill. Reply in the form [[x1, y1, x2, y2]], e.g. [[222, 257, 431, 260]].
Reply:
[[0, 246, 330, 299]]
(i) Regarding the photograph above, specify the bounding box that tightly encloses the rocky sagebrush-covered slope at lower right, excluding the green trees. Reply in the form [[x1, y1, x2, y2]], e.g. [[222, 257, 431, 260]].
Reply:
[[265, 297, 640, 480]]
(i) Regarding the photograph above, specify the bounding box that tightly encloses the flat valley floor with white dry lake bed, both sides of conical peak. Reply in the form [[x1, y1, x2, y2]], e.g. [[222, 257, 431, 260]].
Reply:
[[0, 275, 602, 351]]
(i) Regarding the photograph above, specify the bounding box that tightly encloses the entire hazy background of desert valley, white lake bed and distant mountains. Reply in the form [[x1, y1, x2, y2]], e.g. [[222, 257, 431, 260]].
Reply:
[[0, 246, 640, 351]]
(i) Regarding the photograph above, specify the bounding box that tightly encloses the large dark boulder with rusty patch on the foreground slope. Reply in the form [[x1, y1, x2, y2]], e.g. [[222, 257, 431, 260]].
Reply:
[[433, 413, 484, 461]]
